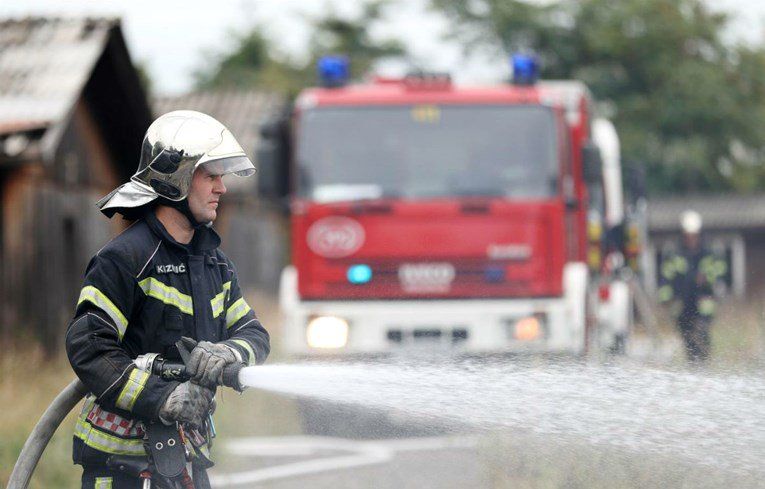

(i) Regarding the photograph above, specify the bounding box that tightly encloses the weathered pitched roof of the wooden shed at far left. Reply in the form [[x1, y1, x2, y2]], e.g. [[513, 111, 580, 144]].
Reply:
[[0, 17, 151, 177]]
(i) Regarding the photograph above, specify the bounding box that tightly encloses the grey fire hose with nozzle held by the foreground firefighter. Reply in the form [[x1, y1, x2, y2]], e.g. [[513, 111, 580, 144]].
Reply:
[[7, 341, 244, 489]]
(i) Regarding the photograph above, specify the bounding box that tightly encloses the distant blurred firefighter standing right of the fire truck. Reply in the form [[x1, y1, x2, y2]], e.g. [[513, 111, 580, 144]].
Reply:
[[658, 210, 727, 362]]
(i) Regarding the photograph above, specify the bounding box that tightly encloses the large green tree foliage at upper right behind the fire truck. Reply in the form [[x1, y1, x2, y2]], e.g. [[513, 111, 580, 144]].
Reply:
[[431, 0, 765, 193]]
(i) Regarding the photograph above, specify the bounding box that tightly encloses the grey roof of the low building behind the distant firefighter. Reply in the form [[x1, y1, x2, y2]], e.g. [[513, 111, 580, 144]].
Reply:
[[648, 194, 765, 231]]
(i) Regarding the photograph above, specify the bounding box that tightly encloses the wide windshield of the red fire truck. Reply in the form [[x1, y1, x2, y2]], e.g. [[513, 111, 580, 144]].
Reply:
[[296, 105, 559, 202]]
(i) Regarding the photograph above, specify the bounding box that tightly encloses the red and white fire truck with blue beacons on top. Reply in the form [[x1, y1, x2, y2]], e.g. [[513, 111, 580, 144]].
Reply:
[[258, 55, 632, 354]]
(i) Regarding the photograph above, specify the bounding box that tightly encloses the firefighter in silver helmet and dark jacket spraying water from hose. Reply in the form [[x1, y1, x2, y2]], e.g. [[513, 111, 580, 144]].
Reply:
[[66, 111, 269, 488]]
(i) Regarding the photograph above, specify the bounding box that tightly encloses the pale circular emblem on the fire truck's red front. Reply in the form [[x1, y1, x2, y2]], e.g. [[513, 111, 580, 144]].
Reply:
[[307, 216, 364, 258]]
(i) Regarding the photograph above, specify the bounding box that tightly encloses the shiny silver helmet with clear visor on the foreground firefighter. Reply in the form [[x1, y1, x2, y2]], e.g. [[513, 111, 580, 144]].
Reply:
[[96, 110, 255, 217]]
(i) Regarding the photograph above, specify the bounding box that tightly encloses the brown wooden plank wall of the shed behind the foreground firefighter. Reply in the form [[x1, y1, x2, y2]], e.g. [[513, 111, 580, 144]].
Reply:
[[0, 97, 125, 352]]
